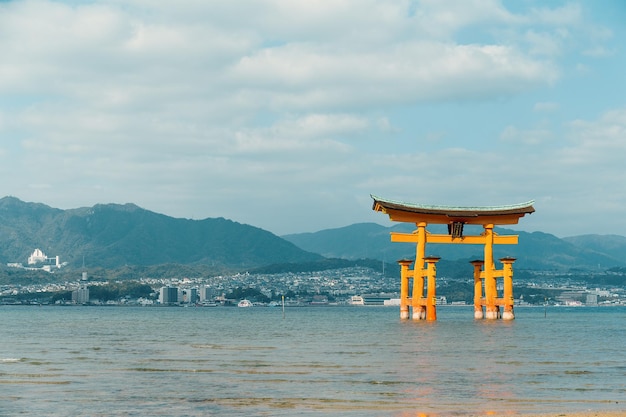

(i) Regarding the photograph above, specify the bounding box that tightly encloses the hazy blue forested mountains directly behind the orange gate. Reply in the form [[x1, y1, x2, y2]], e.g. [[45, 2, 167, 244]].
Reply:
[[283, 223, 626, 271]]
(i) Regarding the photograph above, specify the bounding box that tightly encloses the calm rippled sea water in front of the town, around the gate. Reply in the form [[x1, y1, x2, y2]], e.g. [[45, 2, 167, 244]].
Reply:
[[0, 306, 626, 416]]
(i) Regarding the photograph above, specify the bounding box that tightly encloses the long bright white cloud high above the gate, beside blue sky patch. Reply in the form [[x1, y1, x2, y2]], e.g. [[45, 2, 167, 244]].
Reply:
[[232, 42, 558, 110]]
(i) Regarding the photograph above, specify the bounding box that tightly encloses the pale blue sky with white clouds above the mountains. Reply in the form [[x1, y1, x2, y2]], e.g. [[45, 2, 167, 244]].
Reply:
[[0, 0, 626, 237]]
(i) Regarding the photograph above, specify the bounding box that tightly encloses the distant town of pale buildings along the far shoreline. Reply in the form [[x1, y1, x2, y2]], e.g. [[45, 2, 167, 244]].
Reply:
[[0, 258, 626, 307]]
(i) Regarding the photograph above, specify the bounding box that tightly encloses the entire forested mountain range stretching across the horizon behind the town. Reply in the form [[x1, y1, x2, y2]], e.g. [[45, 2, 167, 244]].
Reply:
[[0, 197, 626, 275]]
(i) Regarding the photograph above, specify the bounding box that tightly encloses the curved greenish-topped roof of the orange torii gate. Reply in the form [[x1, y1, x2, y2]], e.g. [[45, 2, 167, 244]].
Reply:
[[371, 195, 535, 225]]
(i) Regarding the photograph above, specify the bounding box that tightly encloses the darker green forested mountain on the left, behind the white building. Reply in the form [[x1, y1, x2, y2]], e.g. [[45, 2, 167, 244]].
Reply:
[[0, 197, 322, 268]]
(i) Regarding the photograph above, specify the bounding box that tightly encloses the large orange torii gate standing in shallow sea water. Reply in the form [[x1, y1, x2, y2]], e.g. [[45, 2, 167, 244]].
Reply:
[[371, 195, 535, 320]]
